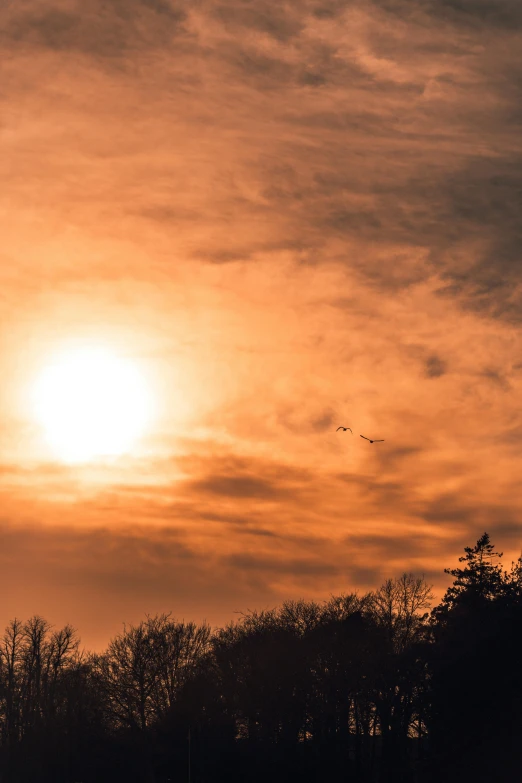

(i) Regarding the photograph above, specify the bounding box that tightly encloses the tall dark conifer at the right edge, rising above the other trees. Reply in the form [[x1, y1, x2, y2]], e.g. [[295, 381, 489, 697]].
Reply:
[[428, 533, 522, 781]]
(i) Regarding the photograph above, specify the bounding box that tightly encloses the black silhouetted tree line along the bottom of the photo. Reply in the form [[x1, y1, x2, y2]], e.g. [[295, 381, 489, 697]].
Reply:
[[0, 533, 522, 783]]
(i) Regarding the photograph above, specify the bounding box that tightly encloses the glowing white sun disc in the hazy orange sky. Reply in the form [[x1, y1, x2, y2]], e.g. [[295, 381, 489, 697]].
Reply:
[[33, 347, 153, 462]]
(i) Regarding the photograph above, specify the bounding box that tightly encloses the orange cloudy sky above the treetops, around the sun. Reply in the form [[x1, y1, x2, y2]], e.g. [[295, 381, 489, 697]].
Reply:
[[0, 0, 522, 649]]
